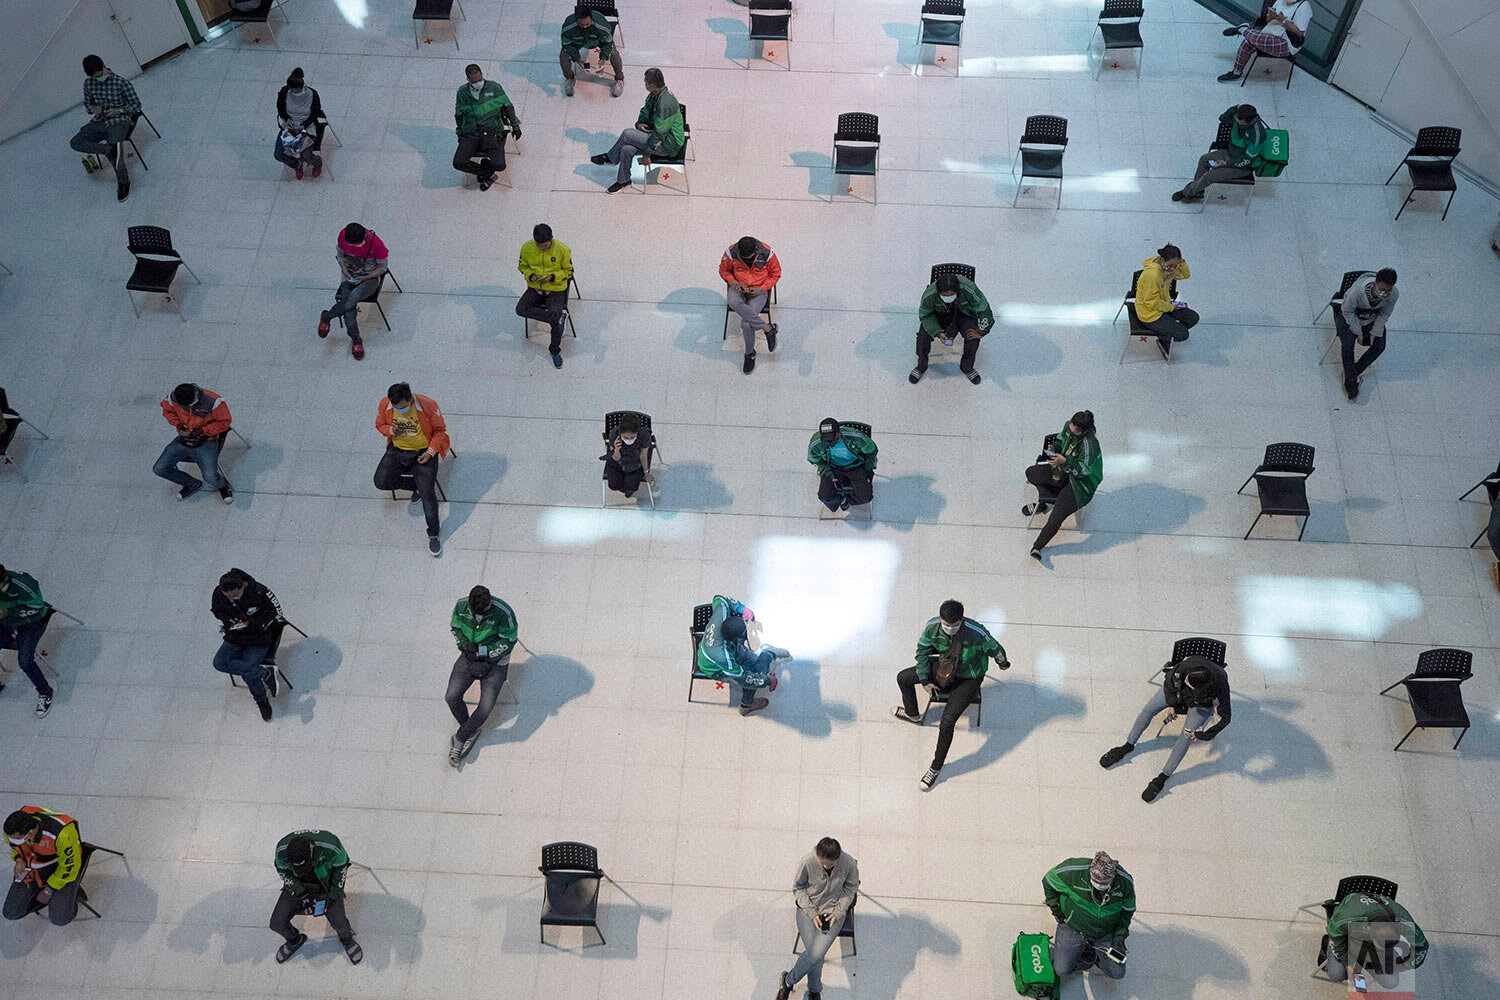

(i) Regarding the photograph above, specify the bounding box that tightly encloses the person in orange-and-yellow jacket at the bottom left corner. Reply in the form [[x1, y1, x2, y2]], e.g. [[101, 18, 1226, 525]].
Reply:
[[5, 805, 89, 927]]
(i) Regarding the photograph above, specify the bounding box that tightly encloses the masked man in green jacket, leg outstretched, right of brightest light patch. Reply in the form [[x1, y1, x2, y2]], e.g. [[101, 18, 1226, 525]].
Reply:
[[891, 598, 1011, 792]]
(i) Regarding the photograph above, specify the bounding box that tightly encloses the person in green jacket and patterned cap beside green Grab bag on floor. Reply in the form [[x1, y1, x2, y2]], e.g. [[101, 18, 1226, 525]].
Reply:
[[1041, 850, 1136, 979]]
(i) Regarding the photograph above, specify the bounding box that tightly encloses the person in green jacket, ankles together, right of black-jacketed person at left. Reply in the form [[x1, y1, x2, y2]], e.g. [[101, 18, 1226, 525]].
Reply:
[[444, 586, 518, 768]]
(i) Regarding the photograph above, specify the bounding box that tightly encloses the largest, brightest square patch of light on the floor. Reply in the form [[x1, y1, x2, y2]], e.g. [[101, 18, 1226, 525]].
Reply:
[[747, 535, 902, 660]]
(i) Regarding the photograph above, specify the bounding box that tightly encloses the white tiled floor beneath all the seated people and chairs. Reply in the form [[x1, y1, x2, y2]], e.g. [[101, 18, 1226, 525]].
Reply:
[[0, 0, 1500, 1000]]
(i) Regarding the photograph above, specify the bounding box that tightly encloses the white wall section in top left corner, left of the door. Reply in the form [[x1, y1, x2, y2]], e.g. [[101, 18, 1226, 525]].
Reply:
[[0, 0, 141, 141]]
